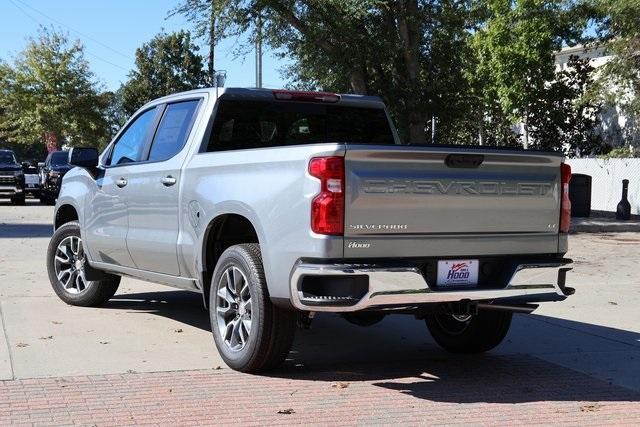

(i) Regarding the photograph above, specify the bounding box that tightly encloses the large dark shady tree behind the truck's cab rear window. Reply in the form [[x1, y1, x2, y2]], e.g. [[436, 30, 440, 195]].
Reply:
[[172, 0, 478, 143]]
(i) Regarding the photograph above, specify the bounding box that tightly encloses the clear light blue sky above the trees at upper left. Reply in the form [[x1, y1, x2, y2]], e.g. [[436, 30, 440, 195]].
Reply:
[[0, 0, 286, 90]]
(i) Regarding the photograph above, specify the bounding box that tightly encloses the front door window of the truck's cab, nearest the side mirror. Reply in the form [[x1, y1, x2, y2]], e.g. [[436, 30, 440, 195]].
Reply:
[[108, 107, 156, 166]]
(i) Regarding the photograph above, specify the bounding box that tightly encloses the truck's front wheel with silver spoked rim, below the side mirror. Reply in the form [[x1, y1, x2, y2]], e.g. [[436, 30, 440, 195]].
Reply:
[[47, 221, 120, 307]]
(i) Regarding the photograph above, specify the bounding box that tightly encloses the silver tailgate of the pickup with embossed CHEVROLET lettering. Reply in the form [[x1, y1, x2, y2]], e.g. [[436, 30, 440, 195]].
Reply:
[[345, 145, 562, 257]]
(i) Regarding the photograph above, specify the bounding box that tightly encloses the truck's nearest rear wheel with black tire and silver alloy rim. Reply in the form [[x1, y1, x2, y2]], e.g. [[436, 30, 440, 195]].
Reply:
[[209, 243, 296, 372]]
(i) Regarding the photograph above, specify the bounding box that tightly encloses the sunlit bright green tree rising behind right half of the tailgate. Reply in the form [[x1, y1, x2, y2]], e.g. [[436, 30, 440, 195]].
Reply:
[[468, 0, 587, 145]]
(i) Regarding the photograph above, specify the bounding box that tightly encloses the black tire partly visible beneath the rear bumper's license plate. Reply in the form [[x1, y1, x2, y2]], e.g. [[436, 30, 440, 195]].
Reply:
[[425, 310, 513, 354]]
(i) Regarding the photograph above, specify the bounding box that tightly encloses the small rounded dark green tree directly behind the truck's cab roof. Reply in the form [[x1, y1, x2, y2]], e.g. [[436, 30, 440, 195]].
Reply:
[[120, 31, 207, 116]]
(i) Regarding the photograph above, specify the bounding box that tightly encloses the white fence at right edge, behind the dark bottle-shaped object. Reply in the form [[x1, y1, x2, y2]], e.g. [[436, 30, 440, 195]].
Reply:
[[566, 159, 640, 214]]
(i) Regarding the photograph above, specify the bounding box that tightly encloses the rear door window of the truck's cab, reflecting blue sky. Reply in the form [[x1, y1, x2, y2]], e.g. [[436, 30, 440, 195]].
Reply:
[[149, 100, 199, 162]]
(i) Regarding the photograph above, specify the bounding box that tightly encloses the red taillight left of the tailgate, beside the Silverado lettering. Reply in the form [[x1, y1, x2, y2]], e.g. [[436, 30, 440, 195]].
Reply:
[[309, 156, 344, 236]]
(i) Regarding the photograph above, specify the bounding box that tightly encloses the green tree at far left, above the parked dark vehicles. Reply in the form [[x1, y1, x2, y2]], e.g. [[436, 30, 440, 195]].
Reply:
[[0, 28, 110, 150]]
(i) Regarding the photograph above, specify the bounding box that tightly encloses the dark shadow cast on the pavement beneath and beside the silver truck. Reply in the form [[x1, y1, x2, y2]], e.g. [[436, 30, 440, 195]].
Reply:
[[104, 291, 640, 403]]
